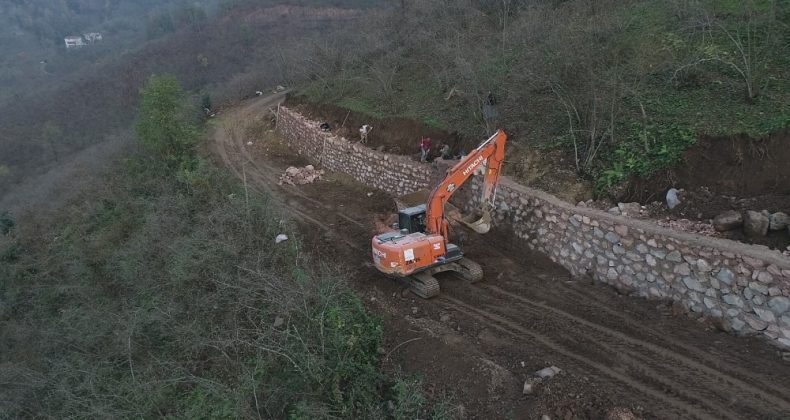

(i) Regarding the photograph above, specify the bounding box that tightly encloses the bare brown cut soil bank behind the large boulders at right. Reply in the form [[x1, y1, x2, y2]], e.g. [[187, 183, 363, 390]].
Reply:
[[621, 131, 790, 250]]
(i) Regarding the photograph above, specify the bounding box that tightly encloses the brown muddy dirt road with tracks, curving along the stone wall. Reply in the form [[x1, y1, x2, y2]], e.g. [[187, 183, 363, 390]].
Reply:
[[210, 96, 790, 419]]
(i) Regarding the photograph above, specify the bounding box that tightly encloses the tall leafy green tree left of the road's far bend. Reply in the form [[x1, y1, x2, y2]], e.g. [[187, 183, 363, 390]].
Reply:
[[135, 75, 198, 170]]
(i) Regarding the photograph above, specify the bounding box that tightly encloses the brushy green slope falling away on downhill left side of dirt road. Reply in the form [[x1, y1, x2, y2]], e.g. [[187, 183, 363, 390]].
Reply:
[[0, 155, 440, 419]]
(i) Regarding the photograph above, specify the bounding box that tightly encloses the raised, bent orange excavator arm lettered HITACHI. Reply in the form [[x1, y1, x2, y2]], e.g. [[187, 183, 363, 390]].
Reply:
[[426, 130, 507, 241]]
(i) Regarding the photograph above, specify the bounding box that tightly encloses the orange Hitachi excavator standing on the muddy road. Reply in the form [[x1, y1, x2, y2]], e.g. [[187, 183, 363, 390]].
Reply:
[[373, 130, 507, 299]]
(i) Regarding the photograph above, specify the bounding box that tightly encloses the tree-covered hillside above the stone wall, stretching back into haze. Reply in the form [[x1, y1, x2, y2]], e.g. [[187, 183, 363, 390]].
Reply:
[[0, 0, 790, 194]]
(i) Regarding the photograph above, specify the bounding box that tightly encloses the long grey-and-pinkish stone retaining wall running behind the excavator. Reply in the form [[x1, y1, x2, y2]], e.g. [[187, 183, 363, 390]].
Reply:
[[278, 108, 790, 347]]
